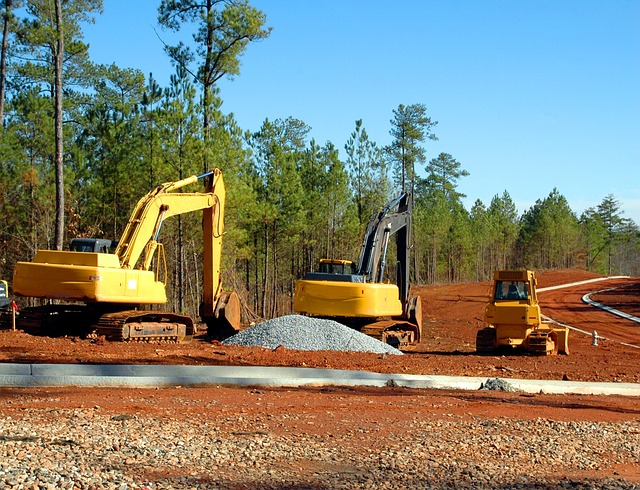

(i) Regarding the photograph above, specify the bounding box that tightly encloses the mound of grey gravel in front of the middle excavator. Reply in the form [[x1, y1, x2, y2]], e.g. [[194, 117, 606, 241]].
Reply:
[[222, 315, 402, 355]]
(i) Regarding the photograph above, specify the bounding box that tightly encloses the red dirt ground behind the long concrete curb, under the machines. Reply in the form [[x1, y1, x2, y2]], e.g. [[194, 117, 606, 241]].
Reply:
[[0, 270, 640, 383]]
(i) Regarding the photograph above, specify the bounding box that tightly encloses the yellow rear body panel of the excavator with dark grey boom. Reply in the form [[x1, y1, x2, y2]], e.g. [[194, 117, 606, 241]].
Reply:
[[293, 279, 403, 318]]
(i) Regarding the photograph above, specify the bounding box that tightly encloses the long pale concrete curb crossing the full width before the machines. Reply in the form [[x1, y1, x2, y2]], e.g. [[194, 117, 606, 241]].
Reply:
[[0, 363, 640, 396]]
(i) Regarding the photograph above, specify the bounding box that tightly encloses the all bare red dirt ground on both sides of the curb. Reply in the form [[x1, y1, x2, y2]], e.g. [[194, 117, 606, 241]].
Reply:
[[0, 270, 640, 484]]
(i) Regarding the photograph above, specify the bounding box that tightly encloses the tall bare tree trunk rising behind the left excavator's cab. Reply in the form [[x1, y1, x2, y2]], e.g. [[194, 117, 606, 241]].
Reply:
[[54, 0, 64, 250]]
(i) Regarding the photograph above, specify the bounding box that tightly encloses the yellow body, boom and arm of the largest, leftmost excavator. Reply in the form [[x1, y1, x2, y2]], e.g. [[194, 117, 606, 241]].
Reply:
[[13, 169, 240, 336]]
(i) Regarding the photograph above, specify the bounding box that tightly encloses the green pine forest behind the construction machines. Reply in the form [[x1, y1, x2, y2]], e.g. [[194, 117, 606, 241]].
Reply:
[[0, 0, 640, 318]]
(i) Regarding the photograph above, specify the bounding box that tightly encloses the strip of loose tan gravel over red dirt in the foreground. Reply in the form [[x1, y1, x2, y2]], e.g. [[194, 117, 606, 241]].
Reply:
[[0, 407, 640, 490]]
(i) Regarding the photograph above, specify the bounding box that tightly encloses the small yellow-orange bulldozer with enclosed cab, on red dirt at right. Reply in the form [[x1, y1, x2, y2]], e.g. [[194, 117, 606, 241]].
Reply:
[[476, 270, 569, 356]]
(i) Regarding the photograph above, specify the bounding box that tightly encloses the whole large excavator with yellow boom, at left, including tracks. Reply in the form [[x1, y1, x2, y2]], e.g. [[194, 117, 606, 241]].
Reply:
[[13, 169, 240, 342]]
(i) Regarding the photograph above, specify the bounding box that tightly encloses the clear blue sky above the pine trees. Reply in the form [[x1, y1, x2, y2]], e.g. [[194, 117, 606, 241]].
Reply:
[[85, 0, 640, 224]]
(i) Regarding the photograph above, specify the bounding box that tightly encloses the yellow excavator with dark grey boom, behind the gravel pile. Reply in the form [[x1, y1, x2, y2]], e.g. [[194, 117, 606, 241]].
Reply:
[[293, 193, 422, 348]]
